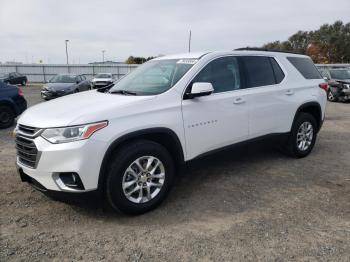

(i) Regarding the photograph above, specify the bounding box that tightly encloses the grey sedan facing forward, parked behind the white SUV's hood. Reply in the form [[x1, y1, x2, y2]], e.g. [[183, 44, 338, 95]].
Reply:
[[41, 74, 91, 100]]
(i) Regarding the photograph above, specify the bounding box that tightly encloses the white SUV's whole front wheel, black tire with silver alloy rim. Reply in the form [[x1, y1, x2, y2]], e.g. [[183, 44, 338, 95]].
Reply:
[[105, 140, 175, 215]]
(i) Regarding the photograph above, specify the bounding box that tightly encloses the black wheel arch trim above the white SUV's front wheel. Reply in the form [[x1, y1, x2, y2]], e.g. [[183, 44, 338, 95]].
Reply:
[[98, 127, 185, 190]]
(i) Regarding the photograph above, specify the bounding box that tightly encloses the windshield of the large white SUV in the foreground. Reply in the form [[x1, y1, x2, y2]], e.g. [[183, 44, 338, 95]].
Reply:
[[109, 59, 197, 95]]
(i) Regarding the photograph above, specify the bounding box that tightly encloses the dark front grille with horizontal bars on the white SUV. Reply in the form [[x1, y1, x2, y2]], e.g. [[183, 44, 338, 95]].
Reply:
[[16, 135, 39, 168]]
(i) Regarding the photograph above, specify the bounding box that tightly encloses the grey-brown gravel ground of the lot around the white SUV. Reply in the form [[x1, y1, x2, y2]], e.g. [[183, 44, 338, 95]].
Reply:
[[0, 86, 350, 261]]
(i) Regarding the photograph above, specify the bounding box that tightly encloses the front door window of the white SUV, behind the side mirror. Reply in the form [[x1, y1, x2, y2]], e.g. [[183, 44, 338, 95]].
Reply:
[[192, 57, 241, 93]]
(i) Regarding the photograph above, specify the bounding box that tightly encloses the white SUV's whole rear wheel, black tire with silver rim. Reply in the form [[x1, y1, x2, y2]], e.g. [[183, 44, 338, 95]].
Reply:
[[285, 113, 317, 158]]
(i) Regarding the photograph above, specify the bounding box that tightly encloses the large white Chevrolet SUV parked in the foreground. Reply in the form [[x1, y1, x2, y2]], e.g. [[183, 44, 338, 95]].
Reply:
[[15, 51, 327, 214]]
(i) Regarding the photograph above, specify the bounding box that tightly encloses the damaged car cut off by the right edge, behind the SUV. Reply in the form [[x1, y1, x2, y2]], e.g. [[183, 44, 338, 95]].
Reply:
[[320, 68, 350, 102]]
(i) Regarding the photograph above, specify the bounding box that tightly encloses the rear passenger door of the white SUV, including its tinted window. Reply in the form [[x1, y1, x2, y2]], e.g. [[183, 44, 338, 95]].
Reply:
[[241, 56, 294, 138]]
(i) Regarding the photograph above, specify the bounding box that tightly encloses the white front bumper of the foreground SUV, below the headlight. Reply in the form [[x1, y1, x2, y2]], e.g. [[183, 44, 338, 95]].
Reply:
[[16, 136, 106, 193]]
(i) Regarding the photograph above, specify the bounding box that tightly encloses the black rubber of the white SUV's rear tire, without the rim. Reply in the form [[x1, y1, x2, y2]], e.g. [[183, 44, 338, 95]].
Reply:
[[288, 113, 317, 158]]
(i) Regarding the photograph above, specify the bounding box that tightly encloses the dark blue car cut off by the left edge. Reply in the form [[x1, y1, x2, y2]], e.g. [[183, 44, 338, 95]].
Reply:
[[0, 81, 27, 128]]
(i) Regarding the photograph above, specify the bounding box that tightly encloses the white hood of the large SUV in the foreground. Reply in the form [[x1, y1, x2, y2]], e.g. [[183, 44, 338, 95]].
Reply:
[[17, 90, 155, 128]]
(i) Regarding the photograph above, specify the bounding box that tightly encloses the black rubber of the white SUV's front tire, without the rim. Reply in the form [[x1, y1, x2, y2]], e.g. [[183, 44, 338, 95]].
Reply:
[[106, 141, 175, 215]]
